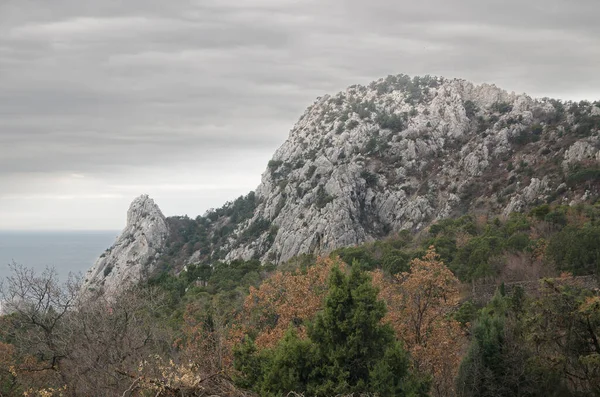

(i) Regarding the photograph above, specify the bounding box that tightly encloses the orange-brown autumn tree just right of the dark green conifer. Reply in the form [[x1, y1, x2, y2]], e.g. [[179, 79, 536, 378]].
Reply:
[[373, 247, 467, 396]]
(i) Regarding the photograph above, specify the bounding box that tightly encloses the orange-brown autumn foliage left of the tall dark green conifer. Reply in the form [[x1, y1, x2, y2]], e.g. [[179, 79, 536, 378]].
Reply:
[[232, 258, 347, 348]]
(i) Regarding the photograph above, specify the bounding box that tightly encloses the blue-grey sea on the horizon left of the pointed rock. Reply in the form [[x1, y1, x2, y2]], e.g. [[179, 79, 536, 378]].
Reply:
[[0, 231, 119, 280]]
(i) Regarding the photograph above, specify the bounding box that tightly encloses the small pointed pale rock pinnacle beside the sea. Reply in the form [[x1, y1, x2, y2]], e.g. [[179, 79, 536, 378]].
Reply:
[[82, 195, 169, 295]]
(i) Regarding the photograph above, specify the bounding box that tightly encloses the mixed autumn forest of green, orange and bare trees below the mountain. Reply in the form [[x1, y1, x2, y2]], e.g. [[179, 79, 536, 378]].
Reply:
[[0, 204, 600, 397]]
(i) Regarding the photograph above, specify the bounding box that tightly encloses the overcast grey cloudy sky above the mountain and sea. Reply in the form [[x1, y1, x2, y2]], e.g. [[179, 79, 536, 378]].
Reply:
[[0, 0, 600, 230]]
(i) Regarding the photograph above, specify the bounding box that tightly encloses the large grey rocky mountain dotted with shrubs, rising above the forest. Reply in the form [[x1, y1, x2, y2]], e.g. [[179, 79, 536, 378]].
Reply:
[[81, 75, 600, 294]]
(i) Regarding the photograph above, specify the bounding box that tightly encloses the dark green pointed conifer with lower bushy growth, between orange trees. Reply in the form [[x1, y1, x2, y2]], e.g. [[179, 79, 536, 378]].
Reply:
[[235, 265, 423, 396]]
